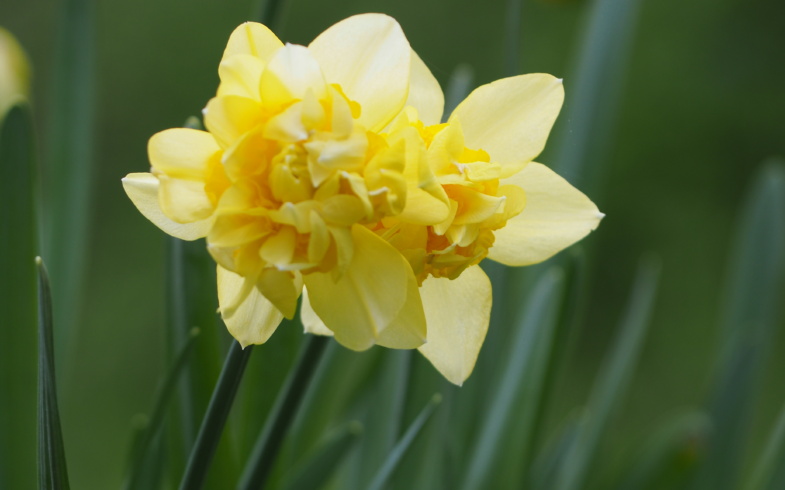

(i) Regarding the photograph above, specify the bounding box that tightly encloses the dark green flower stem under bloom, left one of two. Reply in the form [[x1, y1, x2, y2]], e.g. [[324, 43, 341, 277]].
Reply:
[[180, 342, 253, 490]]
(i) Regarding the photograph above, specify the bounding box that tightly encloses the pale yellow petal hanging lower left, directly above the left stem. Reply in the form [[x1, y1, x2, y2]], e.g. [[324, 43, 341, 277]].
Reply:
[[217, 266, 283, 347]]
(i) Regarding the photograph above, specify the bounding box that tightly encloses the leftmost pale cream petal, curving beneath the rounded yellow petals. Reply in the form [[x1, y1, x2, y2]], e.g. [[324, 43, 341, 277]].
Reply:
[[123, 173, 213, 240]]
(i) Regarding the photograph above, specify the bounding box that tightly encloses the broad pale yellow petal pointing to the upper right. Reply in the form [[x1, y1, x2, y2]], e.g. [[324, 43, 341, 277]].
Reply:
[[450, 73, 564, 163]]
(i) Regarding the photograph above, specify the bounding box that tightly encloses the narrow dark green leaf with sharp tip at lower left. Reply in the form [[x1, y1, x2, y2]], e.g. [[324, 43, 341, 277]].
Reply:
[[36, 257, 70, 490]]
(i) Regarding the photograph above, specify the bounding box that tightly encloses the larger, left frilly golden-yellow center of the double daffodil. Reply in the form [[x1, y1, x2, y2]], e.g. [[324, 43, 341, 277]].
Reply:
[[205, 85, 406, 282]]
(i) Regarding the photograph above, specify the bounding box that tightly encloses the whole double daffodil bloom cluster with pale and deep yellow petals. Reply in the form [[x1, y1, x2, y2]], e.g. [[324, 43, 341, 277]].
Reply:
[[123, 14, 602, 384]]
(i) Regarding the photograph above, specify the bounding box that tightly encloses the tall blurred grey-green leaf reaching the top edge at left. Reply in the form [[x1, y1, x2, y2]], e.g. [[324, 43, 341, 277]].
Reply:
[[42, 0, 96, 368]]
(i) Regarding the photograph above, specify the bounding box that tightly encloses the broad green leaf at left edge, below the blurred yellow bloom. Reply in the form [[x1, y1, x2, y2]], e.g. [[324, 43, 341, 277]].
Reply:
[[0, 103, 37, 488]]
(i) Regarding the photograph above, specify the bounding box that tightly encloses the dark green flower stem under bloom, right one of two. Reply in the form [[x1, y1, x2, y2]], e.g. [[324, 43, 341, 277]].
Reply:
[[237, 335, 330, 490]]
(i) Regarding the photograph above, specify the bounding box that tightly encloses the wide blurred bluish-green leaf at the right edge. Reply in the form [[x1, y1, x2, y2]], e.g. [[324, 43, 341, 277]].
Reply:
[[695, 161, 785, 490]]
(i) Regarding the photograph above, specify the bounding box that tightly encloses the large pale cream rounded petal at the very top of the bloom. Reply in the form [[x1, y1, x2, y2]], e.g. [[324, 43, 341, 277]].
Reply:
[[308, 14, 411, 131]]
